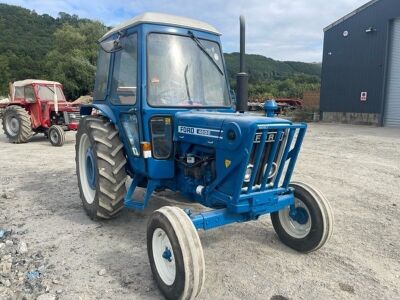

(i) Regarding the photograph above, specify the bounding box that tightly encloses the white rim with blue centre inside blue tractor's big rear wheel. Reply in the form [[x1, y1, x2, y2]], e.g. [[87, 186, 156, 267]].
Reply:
[[79, 133, 96, 204]]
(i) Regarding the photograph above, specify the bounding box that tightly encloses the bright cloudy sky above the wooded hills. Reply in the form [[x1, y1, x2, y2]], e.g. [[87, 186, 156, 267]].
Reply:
[[2, 0, 368, 62]]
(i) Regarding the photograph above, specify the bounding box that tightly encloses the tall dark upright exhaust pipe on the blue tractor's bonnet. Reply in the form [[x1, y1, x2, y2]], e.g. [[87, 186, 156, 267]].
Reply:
[[236, 16, 249, 113]]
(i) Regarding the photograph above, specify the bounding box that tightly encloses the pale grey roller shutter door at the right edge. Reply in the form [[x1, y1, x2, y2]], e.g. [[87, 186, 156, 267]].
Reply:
[[384, 18, 400, 127]]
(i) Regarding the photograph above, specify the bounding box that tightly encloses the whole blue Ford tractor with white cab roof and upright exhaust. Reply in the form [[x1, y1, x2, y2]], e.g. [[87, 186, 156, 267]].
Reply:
[[76, 13, 333, 299]]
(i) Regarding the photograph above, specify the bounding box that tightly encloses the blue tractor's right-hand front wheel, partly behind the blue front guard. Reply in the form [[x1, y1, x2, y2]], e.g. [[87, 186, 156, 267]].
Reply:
[[271, 182, 333, 253]]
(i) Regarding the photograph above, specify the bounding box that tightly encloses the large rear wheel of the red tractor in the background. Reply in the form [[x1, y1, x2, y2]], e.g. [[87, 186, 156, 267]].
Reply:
[[3, 105, 33, 144]]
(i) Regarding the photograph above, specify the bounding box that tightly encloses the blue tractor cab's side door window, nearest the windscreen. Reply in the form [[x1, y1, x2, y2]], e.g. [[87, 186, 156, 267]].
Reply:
[[111, 33, 137, 105]]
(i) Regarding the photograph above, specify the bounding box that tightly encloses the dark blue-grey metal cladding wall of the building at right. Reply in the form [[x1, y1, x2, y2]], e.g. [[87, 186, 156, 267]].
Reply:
[[321, 0, 400, 114]]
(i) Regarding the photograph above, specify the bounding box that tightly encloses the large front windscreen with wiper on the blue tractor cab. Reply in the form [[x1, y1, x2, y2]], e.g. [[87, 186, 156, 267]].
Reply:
[[147, 33, 230, 107]]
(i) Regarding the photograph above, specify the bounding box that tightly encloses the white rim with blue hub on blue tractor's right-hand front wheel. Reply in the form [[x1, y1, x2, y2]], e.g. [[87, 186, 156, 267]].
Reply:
[[279, 198, 312, 239]]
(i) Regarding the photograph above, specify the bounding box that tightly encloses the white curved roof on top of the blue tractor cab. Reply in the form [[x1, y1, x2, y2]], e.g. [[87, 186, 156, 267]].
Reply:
[[100, 12, 221, 41]]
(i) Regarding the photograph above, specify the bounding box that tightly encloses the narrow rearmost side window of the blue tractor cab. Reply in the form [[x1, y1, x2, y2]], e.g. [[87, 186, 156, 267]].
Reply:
[[93, 47, 111, 100]]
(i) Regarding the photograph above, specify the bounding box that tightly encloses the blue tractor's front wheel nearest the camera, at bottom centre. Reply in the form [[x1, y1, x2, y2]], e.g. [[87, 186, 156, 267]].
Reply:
[[147, 206, 205, 299]]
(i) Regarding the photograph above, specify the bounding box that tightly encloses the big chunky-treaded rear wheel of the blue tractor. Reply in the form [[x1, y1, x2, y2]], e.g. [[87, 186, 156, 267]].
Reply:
[[75, 116, 126, 219]]
